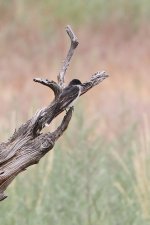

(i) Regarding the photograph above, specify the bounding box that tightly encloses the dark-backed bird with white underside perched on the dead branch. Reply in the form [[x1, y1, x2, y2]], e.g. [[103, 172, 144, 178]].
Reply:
[[45, 79, 82, 127]]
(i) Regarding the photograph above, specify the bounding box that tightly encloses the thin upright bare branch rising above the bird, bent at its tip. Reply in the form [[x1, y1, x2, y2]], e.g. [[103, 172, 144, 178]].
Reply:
[[57, 25, 79, 89]]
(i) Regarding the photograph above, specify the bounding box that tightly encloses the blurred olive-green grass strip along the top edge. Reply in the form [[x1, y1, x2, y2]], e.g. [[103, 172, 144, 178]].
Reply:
[[0, 0, 150, 30]]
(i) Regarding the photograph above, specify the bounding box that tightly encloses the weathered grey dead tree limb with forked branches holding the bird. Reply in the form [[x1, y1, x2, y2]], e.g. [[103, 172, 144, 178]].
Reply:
[[0, 26, 108, 200]]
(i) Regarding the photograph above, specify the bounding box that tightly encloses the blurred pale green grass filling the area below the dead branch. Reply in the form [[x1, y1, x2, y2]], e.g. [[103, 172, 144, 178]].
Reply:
[[0, 111, 150, 225]]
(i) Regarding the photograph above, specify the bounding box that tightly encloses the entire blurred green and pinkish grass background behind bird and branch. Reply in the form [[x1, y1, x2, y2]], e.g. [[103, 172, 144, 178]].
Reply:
[[0, 0, 150, 225]]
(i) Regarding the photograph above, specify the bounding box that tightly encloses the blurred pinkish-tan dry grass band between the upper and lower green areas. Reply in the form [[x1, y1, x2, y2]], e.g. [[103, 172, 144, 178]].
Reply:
[[0, 24, 150, 137]]
